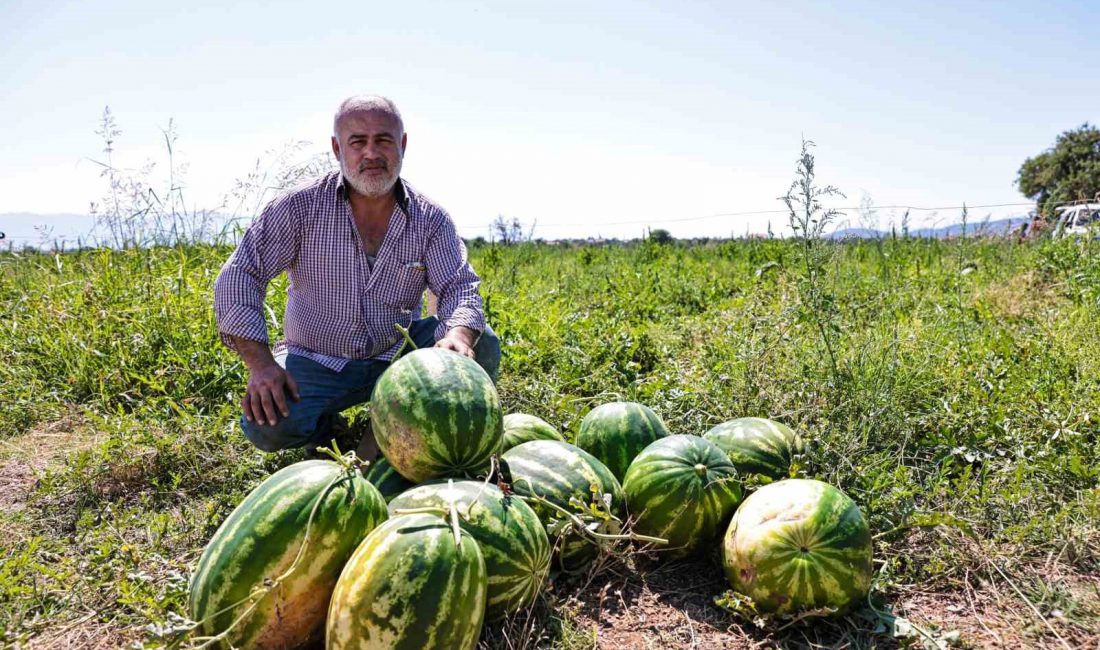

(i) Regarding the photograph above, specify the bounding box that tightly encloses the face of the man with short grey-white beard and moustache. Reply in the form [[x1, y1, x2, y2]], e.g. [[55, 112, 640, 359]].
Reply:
[[332, 111, 406, 197]]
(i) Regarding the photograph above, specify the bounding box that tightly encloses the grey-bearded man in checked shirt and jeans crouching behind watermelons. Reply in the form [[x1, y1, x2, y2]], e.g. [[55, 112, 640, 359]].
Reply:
[[215, 96, 501, 460]]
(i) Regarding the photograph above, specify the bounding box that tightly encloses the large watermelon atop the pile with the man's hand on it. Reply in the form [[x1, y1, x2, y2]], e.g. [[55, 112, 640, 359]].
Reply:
[[371, 348, 504, 483]]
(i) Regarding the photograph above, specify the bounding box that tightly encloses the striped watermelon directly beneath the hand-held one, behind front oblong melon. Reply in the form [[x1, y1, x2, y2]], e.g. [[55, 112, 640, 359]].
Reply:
[[389, 480, 550, 620]]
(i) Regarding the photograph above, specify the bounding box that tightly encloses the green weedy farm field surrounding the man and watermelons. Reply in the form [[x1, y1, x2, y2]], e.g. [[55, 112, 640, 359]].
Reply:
[[0, 239, 1100, 649]]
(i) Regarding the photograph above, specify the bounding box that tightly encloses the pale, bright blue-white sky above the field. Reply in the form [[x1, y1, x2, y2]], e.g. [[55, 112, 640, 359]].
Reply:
[[0, 0, 1100, 239]]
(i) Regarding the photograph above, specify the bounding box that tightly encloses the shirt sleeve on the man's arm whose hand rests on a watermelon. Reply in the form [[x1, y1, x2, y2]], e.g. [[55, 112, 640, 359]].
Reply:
[[425, 213, 485, 341]]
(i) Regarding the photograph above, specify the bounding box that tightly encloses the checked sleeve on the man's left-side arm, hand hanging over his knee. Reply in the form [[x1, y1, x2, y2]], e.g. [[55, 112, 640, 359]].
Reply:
[[213, 196, 300, 349]]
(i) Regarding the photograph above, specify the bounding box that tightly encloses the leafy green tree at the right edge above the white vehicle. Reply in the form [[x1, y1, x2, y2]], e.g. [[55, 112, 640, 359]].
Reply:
[[1016, 122, 1100, 213]]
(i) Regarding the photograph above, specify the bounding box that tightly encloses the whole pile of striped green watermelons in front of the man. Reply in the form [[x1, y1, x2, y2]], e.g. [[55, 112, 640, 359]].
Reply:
[[189, 349, 871, 649]]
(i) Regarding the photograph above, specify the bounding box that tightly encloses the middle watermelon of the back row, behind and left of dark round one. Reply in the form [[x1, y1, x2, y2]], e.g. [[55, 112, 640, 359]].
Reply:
[[576, 401, 669, 481]]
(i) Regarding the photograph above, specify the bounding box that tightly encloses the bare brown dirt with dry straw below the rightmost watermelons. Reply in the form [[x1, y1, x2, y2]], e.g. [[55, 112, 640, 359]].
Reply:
[[569, 560, 1100, 650]]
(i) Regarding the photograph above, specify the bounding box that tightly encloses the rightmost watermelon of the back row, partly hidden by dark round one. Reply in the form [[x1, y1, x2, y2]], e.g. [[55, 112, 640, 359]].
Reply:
[[703, 418, 805, 478]]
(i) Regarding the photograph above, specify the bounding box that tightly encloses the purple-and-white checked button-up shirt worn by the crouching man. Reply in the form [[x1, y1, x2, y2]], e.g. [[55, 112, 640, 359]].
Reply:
[[213, 172, 485, 372]]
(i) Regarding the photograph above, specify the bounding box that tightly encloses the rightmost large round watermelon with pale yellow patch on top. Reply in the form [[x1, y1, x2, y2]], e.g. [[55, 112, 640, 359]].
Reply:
[[723, 478, 871, 613]]
